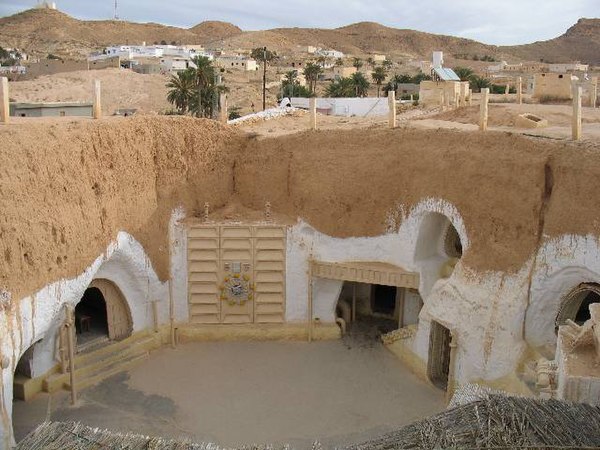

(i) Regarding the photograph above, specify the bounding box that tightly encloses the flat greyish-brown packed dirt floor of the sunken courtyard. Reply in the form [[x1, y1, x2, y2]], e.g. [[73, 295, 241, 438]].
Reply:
[[13, 342, 445, 450]]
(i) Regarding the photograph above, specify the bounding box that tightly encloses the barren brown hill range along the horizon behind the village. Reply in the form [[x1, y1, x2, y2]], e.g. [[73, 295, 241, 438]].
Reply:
[[0, 9, 600, 64]]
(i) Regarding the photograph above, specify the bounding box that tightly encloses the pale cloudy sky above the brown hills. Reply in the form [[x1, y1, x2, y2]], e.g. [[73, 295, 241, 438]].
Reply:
[[0, 0, 600, 45]]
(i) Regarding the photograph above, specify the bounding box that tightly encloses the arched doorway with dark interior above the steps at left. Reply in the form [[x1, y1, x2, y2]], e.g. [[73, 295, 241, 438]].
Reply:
[[75, 279, 133, 349]]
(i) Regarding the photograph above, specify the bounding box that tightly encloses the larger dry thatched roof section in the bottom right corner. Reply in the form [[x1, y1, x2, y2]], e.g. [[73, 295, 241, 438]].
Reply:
[[346, 394, 600, 450]]
